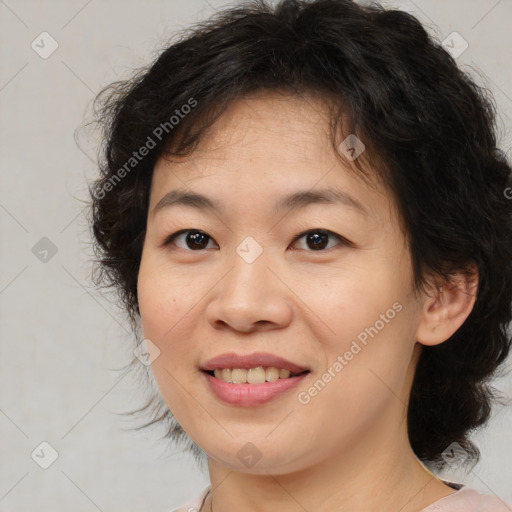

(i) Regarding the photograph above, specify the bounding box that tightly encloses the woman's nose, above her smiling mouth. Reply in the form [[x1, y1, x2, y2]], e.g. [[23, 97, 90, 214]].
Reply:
[[206, 247, 293, 333]]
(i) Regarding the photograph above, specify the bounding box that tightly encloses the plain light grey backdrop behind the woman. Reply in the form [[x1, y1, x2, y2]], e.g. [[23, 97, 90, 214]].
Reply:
[[0, 0, 512, 512]]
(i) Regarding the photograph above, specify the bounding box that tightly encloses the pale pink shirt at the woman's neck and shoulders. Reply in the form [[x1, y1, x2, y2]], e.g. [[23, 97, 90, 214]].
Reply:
[[171, 486, 512, 512]]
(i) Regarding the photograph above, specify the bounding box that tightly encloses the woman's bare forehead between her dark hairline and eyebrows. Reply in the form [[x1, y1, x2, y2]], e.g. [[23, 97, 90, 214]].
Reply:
[[151, 91, 390, 226]]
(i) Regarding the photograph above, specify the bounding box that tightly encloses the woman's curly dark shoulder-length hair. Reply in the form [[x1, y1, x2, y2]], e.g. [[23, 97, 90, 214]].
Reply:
[[89, 0, 512, 468]]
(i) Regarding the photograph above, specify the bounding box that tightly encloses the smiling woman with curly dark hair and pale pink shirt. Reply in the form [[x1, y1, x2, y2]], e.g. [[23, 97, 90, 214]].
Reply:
[[91, 0, 512, 512]]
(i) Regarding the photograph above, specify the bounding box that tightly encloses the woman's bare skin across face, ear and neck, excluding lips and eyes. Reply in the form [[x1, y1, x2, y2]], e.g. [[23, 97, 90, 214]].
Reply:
[[138, 92, 476, 512]]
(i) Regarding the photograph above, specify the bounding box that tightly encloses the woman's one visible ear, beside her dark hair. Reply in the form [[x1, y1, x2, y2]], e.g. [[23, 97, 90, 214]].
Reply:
[[416, 265, 478, 346]]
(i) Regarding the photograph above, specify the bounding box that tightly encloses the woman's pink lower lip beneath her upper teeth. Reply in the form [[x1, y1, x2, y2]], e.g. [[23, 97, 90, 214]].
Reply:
[[203, 372, 309, 407]]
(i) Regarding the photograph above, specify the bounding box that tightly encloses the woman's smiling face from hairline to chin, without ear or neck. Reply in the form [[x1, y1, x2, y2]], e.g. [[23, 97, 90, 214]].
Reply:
[[138, 93, 428, 474]]
